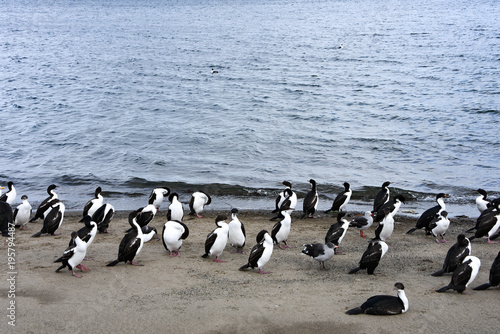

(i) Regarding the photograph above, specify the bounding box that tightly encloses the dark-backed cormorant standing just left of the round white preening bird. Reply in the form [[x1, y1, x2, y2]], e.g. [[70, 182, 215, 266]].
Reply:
[[106, 211, 144, 267]]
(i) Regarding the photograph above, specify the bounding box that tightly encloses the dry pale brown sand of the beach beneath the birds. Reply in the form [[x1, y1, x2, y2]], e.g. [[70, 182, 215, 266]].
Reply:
[[0, 211, 500, 334]]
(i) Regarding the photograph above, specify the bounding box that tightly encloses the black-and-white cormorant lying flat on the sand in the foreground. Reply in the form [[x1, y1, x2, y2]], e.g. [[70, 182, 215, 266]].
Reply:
[[346, 282, 409, 315]]
